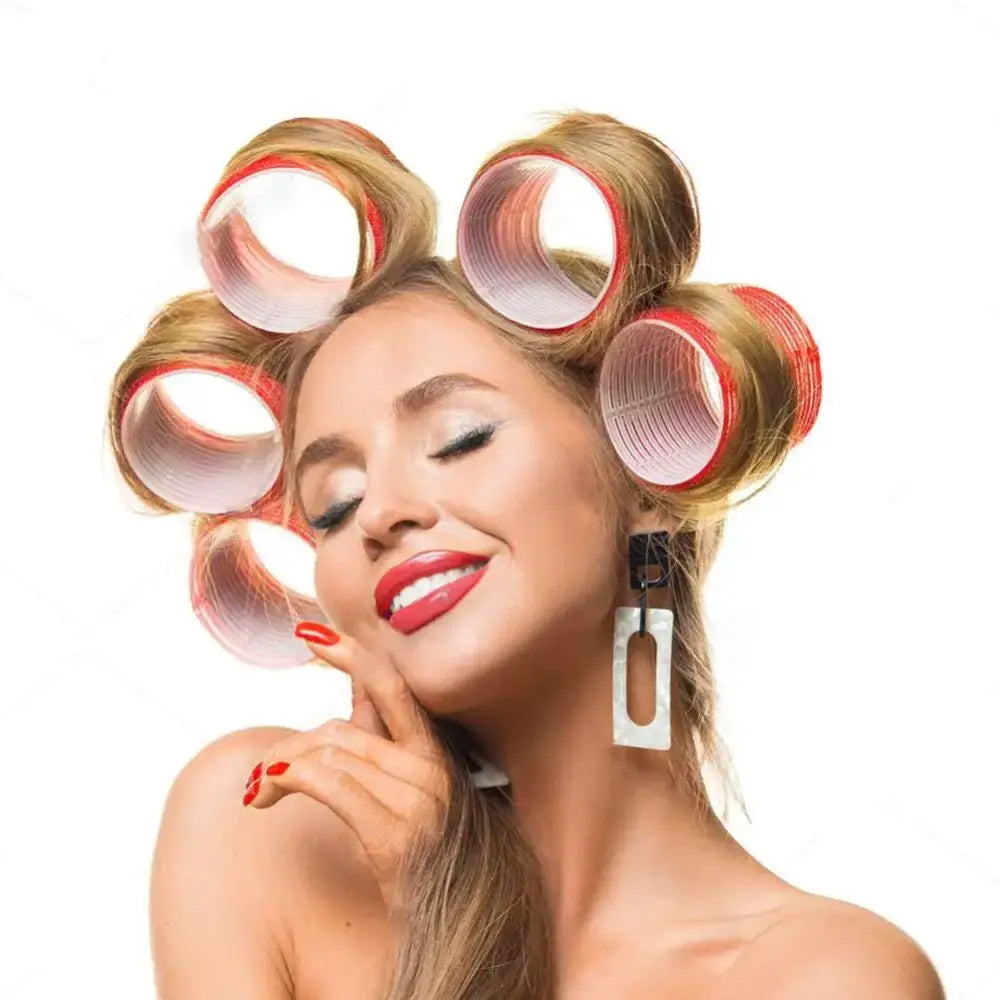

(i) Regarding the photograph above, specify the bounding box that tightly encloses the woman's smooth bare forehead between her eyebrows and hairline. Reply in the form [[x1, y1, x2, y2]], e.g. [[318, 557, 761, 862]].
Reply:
[[295, 292, 541, 447]]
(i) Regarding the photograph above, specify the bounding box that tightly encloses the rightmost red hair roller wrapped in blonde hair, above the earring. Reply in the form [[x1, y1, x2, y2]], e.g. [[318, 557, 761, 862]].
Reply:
[[598, 285, 822, 502]]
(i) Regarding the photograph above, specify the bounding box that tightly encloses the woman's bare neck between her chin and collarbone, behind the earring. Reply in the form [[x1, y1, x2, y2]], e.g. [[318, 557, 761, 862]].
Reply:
[[450, 600, 792, 950]]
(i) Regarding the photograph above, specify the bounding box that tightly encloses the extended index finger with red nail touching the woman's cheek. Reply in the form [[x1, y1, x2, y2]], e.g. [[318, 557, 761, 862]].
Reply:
[[305, 634, 440, 755]]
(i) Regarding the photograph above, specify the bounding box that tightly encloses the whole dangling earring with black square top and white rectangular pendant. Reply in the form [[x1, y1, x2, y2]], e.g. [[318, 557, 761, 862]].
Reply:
[[612, 531, 674, 750]]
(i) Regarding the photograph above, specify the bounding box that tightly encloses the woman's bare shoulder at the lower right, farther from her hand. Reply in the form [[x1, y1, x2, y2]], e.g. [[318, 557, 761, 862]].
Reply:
[[720, 894, 945, 1000]]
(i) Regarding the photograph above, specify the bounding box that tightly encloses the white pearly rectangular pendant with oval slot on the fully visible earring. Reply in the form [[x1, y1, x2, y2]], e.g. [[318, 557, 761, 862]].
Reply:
[[613, 607, 674, 750]]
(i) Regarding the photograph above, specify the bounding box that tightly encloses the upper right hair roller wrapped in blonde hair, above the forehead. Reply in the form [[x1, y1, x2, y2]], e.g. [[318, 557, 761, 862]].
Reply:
[[457, 112, 700, 362]]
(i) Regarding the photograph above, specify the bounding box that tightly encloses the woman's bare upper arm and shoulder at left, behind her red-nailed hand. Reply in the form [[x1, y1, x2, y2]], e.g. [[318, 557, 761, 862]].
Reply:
[[149, 727, 294, 1000]]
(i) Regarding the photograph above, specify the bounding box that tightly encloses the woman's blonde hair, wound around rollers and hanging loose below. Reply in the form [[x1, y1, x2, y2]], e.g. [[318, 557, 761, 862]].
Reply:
[[109, 112, 812, 1000]]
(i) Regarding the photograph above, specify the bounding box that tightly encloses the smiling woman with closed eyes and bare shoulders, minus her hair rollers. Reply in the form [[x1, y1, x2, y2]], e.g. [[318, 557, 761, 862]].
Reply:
[[111, 111, 943, 1000]]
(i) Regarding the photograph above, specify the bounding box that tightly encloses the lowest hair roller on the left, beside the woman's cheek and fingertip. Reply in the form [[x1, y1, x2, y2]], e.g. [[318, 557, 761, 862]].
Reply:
[[190, 497, 326, 667]]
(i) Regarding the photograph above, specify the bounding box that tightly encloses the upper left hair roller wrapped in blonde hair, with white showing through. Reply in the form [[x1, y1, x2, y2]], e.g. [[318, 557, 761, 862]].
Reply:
[[197, 118, 436, 334]]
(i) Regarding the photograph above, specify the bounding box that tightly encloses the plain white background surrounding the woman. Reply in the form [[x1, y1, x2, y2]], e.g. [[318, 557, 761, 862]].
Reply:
[[0, 0, 1000, 1000]]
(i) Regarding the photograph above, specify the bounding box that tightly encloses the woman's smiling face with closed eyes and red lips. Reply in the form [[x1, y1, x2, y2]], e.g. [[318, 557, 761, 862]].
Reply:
[[292, 292, 622, 714]]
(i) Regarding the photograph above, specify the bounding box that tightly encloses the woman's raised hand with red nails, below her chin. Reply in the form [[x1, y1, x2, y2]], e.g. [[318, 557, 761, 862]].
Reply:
[[244, 636, 451, 911]]
